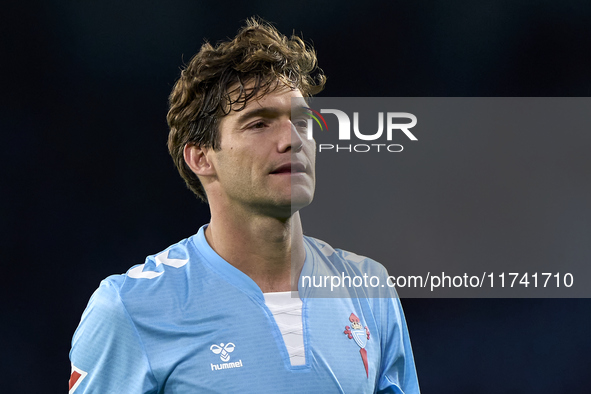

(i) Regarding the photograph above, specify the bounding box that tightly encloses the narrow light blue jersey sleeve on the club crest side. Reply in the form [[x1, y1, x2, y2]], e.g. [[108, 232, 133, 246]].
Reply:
[[377, 291, 420, 394]]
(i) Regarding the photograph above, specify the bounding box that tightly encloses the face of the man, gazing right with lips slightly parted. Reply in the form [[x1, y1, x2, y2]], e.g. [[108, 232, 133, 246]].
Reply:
[[208, 85, 316, 218]]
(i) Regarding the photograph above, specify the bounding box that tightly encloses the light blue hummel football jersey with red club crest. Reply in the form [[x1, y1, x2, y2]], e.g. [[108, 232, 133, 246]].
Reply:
[[70, 226, 419, 394]]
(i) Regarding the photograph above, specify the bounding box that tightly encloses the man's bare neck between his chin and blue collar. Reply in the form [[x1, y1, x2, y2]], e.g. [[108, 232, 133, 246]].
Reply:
[[205, 203, 306, 293]]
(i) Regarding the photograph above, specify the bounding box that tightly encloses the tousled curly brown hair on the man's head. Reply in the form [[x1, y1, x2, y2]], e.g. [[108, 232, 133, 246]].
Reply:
[[166, 18, 326, 202]]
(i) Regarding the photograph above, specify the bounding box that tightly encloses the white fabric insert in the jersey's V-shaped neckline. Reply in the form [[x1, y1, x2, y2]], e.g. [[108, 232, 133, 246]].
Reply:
[[263, 291, 306, 365]]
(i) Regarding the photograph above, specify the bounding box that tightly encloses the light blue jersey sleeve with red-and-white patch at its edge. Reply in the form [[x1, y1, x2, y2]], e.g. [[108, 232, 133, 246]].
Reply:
[[69, 279, 158, 394]]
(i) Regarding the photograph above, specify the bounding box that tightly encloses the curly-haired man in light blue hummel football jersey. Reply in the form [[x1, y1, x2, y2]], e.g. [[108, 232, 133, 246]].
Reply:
[[70, 20, 419, 394]]
